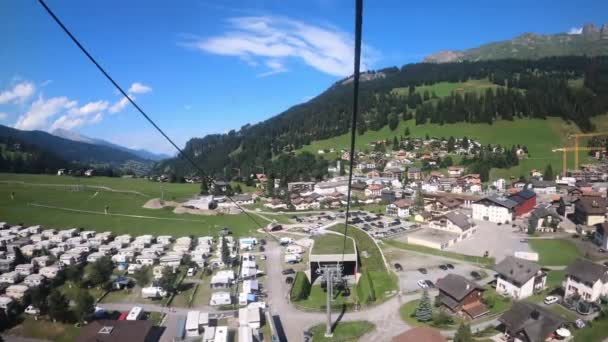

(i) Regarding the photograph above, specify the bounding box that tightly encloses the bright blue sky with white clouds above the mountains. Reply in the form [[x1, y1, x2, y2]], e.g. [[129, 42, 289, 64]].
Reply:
[[0, 0, 608, 152]]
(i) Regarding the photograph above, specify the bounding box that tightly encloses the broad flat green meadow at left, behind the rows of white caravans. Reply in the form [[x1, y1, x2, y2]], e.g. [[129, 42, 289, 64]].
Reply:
[[0, 173, 267, 236]]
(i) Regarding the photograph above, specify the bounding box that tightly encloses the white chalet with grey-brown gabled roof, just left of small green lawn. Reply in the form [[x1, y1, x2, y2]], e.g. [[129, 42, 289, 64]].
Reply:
[[494, 256, 547, 300]]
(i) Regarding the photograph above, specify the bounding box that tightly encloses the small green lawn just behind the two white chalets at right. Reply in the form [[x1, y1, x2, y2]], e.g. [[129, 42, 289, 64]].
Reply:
[[528, 239, 582, 266]]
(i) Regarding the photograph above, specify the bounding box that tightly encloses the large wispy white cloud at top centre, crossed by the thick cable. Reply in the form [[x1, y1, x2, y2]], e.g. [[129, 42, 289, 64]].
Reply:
[[184, 16, 377, 76]]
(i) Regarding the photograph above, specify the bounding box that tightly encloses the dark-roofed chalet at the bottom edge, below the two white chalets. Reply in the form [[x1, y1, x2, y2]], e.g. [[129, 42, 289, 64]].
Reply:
[[498, 301, 566, 342]]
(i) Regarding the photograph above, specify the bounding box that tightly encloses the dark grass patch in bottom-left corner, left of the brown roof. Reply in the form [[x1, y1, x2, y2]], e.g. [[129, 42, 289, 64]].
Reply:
[[6, 316, 80, 342]]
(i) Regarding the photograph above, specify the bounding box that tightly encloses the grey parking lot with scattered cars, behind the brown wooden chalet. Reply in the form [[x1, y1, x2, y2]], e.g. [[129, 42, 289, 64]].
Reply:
[[384, 248, 494, 293]]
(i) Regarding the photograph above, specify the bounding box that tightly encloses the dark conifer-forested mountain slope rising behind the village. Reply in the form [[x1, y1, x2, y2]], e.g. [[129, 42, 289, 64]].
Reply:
[[157, 56, 608, 182]]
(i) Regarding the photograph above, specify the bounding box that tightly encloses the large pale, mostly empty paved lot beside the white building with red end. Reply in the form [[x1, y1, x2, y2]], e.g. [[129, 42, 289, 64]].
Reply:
[[446, 221, 532, 262]]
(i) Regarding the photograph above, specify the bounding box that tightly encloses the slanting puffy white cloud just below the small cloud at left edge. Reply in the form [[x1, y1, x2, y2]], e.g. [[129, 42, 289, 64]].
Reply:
[[15, 96, 76, 130]]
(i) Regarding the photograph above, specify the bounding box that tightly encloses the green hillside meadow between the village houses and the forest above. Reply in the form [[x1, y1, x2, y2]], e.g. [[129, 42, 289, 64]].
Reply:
[[302, 117, 583, 178]]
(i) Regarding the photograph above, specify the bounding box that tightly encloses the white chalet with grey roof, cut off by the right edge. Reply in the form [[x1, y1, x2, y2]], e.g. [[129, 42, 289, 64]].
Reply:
[[563, 259, 608, 302]]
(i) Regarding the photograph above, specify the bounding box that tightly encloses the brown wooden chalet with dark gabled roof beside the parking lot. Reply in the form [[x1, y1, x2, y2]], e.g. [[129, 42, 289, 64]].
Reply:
[[437, 274, 488, 319]]
